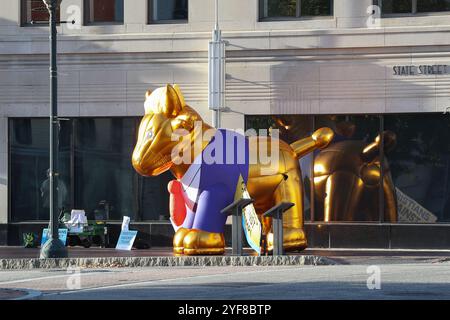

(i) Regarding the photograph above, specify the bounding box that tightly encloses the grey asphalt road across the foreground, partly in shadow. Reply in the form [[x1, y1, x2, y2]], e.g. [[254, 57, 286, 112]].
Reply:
[[0, 261, 450, 300]]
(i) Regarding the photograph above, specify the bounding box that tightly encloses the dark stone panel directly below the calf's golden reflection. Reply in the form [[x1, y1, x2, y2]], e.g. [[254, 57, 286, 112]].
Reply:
[[328, 224, 389, 249]]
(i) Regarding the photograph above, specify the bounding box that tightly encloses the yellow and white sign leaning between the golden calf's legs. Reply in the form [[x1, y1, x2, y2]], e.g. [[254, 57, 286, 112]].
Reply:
[[234, 176, 262, 255]]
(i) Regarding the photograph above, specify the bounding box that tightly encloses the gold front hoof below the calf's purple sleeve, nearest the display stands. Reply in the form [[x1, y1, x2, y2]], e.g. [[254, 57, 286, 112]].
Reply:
[[183, 230, 225, 256]]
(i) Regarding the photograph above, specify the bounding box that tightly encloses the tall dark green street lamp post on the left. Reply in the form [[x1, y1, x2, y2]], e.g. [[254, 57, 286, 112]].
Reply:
[[41, 0, 67, 259]]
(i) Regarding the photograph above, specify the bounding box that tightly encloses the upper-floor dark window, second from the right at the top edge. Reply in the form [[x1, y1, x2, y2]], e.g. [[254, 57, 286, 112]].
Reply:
[[259, 0, 333, 19]]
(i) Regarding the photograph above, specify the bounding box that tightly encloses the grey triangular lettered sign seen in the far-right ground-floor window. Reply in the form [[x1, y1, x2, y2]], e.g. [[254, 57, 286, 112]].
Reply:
[[395, 188, 437, 223]]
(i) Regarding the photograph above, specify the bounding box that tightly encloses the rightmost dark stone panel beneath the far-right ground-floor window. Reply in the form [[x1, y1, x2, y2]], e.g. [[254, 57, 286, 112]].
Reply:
[[391, 225, 450, 249]]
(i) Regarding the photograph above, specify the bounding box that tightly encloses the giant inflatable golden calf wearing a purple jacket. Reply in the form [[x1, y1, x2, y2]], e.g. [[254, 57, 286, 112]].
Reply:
[[132, 85, 334, 255]]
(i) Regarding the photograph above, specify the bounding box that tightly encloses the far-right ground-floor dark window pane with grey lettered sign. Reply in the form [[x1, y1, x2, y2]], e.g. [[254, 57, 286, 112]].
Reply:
[[385, 114, 450, 223]]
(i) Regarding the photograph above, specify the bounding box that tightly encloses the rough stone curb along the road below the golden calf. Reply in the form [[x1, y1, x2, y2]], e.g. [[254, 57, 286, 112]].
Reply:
[[0, 255, 337, 270]]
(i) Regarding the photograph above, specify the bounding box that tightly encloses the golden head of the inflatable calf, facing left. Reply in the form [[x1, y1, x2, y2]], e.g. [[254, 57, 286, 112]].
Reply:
[[132, 85, 205, 176]]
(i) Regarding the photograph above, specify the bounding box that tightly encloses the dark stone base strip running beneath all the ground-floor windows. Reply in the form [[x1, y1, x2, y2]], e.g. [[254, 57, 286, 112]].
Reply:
[[4, 222, 450, 249]]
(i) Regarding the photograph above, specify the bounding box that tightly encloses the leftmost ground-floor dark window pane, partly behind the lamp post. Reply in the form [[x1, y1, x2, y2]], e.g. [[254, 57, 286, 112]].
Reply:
[[9, 119, 71, 222]]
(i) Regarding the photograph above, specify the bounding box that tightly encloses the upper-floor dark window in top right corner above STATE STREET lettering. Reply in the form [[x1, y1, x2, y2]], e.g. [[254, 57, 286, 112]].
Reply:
[[374, 0, 450, 14]]
